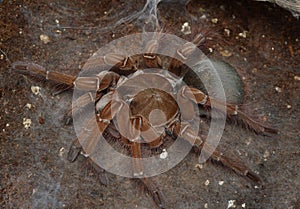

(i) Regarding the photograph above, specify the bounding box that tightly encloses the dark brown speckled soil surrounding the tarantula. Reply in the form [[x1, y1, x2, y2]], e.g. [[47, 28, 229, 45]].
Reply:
[[0, 0, 300, 209]]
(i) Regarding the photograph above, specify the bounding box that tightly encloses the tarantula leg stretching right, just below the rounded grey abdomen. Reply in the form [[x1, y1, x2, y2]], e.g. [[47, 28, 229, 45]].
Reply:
[[179, 86, 278, 134]]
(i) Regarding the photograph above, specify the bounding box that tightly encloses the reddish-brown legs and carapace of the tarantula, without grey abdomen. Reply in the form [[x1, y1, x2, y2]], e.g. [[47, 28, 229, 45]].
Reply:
[[13, 31, 277, 208]]
